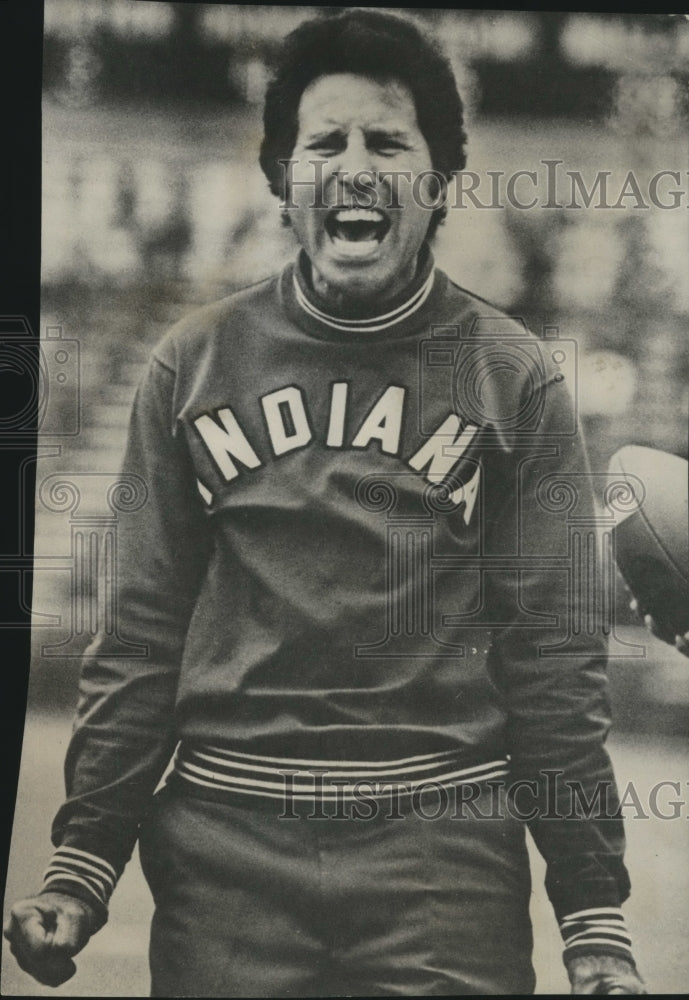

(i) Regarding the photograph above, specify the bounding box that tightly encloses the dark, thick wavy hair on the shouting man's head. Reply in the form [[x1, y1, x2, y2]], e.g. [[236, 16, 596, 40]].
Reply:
[[259, 8, 467, 239]]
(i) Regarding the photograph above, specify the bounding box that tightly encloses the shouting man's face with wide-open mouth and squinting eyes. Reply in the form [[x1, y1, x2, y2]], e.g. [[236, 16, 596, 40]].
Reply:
[[288, 73, 432, 304]]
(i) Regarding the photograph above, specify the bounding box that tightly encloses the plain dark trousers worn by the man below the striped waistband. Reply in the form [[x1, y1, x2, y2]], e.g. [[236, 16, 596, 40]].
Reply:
[[140, 786, 534, 998]]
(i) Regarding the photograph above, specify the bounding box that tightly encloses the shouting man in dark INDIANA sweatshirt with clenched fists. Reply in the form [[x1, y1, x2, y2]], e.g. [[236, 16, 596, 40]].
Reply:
[[6, 10, 643, 997]]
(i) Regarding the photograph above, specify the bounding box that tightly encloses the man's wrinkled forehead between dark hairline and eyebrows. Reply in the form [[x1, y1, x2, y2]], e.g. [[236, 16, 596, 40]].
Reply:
[[298, 73, 419, 134]]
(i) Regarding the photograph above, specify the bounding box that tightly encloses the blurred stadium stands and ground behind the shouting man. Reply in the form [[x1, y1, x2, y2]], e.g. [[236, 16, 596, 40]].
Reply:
[[3, 0, 689, 996]]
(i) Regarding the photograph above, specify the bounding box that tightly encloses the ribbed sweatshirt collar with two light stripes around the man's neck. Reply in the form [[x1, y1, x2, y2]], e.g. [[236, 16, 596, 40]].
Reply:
[[280, 244, 447, 341]]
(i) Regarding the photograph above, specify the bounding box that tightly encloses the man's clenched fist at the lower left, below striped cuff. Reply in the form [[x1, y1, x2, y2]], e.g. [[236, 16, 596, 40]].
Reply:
[[4, 892, 102, 986]]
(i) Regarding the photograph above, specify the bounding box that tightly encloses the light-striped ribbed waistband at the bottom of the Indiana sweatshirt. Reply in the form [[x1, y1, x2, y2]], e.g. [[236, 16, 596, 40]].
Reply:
[[175, 743, 509, 803]]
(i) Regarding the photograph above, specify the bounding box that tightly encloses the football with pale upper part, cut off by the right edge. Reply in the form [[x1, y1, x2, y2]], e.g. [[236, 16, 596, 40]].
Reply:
[[607, 445, 689, 642]]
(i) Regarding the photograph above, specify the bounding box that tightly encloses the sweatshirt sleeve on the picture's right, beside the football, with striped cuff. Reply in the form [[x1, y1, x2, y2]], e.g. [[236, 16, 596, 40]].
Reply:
[[487, 372, 631, 960]]
